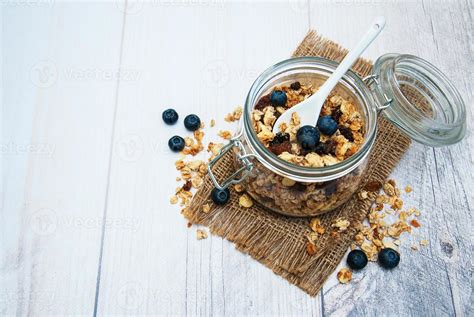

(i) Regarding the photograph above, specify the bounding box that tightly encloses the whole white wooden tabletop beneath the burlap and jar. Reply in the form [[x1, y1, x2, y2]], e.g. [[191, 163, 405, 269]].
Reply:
[[0, 0, 474, 316]]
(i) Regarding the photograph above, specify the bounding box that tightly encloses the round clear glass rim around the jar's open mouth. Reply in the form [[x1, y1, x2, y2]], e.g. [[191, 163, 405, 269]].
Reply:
[[242, 56, 377, 182]]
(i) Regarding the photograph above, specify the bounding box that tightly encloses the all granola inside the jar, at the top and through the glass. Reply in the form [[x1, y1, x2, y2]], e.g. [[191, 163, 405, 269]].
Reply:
[[236, 82, 367, 216]]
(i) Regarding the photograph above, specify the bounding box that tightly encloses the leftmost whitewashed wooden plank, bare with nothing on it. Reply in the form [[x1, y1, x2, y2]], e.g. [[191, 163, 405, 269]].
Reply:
[[0, 1, 123, 315]]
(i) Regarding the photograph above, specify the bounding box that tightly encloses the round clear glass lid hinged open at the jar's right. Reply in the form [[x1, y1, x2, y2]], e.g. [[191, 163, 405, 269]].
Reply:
[[366, 54, 466, 146]]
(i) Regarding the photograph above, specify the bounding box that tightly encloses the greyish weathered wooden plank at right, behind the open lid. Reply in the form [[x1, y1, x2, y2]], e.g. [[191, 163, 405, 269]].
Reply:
[[310, 1, 474, 316]]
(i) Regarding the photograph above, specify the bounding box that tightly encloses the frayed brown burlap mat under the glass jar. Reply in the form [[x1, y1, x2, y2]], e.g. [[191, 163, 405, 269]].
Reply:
[[184, 31, 410, 296]]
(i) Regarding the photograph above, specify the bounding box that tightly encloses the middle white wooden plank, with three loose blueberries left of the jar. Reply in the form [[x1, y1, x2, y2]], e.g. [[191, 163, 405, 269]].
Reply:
[[98, 1, 321, 315]]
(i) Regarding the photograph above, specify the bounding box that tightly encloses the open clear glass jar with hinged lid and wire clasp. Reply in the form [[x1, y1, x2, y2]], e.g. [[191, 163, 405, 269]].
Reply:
[[209, 54, 466, 216]]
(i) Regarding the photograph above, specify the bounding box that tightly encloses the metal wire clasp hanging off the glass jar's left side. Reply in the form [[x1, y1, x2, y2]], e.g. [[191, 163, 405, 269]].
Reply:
[[207, 134, 255, 190]]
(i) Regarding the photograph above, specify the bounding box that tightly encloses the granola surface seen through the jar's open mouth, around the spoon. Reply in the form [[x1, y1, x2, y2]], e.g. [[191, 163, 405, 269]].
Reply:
[[252, 82, 365, 167]]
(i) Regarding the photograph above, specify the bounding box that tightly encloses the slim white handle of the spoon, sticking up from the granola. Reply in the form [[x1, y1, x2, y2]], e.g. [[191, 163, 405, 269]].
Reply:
[[318, 17, 385, 100]]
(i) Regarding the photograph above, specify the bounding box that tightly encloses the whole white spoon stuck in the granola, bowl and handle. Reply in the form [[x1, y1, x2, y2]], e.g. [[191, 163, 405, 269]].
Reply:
[[273, 17, 385, 133]]
